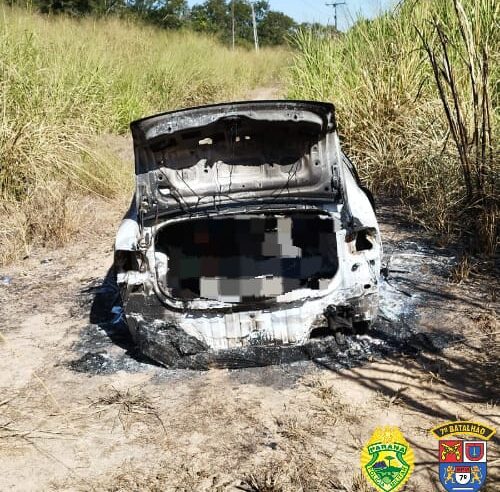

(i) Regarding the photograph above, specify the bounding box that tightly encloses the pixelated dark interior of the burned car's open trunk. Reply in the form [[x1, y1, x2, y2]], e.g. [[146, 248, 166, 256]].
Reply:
[[155, 213, 338, 302]]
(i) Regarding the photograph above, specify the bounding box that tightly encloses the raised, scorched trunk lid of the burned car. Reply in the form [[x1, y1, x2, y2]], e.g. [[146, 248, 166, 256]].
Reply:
[[131, 101, 341, 218]]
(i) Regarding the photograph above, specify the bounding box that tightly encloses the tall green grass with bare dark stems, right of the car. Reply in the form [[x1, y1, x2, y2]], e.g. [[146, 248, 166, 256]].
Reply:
[[288, 0, 500, 254]]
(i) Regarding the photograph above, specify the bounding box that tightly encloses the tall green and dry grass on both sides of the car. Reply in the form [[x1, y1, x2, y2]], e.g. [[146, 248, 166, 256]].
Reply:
[[0, 0, 500, 263]]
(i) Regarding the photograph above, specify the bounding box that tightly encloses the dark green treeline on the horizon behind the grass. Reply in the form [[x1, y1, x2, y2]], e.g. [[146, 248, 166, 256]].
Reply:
[[9, 0, 330, 46]]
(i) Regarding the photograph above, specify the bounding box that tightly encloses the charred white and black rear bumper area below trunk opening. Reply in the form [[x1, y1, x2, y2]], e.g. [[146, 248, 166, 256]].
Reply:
[[125, 291, 378, 368]]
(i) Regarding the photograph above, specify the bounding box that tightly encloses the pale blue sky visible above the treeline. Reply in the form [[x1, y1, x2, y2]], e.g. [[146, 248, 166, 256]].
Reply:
[[188, 0, 395, 29]]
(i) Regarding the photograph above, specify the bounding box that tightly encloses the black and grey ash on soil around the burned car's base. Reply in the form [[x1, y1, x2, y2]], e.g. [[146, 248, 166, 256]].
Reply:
[[71, 213, 468, 374]]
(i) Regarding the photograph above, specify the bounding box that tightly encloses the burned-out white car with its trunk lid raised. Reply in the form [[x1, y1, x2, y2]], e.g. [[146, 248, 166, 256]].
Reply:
[[114, 101, 381, 367]]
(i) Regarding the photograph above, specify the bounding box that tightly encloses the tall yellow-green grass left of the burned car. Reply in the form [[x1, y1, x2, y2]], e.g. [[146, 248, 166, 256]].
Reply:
[[0, 4, 288, 263]]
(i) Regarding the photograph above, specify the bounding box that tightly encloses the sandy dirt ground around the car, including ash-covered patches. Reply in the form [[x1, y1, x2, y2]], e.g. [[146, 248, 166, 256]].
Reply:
[[0, 132, 500, 492]]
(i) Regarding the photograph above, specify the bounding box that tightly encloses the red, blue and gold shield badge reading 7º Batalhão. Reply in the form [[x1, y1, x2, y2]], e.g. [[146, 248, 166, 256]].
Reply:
[[432, 421, 495, 492]]
